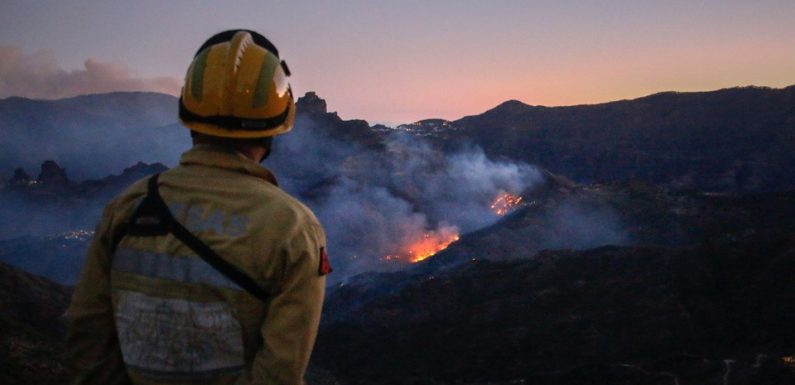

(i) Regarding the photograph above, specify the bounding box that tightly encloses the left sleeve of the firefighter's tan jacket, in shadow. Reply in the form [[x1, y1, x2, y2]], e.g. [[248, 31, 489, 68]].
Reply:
[[66, 205, 129, 385]]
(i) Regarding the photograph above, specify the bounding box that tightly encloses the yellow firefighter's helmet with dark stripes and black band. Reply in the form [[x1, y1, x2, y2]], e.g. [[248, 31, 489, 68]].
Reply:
[[179, 30, 295, 138]]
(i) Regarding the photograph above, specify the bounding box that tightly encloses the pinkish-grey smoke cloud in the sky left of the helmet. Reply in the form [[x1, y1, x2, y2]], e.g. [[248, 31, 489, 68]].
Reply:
[[0, 46, 180, 99]]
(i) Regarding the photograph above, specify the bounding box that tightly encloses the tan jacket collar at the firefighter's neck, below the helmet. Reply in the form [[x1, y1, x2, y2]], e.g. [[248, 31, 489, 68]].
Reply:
[[179, 144, 279, 186]]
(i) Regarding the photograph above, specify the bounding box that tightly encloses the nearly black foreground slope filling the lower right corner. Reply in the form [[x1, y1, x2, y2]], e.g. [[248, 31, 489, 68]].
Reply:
[[317, 233, 795, 384]]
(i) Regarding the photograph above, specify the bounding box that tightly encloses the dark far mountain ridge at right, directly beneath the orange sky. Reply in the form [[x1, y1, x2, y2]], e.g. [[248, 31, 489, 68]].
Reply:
[[432, 86, 795, 192]]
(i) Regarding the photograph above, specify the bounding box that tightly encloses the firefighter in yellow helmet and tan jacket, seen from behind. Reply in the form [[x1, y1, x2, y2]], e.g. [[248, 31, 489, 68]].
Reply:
[[67, 30, 331, 385]]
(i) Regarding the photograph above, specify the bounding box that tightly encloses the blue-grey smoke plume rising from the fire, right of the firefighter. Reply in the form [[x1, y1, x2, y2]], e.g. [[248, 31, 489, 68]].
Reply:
[[266, 115, 541, 279]]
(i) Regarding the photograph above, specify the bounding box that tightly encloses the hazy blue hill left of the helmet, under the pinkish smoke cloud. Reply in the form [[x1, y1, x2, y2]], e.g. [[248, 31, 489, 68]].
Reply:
[[0, 92, 190, 181]]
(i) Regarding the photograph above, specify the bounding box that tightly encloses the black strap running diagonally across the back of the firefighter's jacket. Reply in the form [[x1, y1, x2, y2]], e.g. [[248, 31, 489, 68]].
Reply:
[[128, 174, 268, 301]]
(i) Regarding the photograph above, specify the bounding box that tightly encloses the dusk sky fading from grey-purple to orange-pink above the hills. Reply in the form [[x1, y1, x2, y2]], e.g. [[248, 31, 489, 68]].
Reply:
[[0, 0, 795, 123]]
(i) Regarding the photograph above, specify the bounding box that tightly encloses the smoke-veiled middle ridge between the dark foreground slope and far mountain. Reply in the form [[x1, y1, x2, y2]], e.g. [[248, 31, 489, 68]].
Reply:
[[423, 175, 795, 271]]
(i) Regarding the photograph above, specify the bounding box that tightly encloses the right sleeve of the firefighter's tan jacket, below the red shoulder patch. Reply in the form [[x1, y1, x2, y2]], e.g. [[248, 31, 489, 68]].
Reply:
[[250, 223, 326, 385]]
